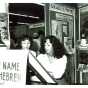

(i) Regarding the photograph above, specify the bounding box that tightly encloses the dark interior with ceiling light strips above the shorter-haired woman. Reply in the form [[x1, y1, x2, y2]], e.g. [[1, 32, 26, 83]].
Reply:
[[9, 3, 45, 48]]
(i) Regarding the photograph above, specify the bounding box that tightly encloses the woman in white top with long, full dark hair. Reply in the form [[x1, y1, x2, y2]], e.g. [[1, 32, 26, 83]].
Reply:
[[37, 36, 67, 84]]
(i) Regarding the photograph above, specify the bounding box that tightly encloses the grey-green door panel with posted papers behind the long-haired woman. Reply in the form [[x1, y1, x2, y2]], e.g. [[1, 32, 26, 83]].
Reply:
[[49, 3, 76, 84]]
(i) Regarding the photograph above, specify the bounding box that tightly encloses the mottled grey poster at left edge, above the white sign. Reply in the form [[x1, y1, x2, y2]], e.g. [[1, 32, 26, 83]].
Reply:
[[0, 13, 9, 45]]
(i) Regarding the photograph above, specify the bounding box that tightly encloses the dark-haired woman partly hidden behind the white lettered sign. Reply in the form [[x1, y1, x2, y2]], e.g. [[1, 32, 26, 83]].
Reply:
[[20, 35, 36, 84]]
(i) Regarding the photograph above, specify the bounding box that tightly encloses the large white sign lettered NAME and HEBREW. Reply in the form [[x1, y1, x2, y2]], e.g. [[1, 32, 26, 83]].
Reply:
[[0, 50, 28, 85]]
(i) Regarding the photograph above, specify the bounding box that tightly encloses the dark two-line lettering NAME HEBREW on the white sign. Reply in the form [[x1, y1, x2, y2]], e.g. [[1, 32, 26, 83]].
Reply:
[[0, 62, 21, 81]]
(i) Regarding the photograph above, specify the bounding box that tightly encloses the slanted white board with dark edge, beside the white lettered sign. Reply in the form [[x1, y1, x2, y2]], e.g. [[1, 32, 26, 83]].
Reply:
[[29, 53, 57, 84]]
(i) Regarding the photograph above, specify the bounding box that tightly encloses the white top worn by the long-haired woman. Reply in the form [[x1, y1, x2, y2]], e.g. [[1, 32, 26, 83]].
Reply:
[[37, 54, 67, 79]]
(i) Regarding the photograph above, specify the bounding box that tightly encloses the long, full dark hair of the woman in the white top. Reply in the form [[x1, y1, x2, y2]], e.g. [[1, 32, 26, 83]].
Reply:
[[40, 35, 66, 58]]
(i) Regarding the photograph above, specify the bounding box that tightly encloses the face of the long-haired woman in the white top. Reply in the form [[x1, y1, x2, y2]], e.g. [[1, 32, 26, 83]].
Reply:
[[45, 39, 53, 55]]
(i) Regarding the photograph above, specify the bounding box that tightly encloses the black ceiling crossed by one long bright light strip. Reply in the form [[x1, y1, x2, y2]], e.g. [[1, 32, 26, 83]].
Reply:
[[9, 3, 44, 23]]
